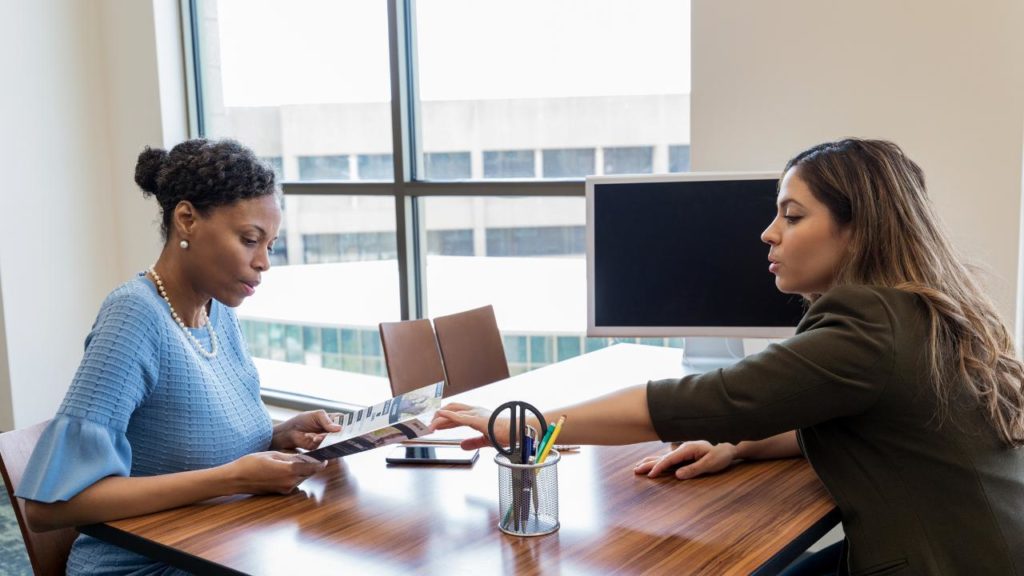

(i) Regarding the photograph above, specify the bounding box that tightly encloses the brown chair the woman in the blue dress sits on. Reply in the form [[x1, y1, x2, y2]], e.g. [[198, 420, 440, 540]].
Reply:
[[0, 420, 78, 576]]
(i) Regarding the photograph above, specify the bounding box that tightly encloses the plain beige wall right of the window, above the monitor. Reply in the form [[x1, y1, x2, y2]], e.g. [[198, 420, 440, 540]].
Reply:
[[690, 0, 1024, 323]]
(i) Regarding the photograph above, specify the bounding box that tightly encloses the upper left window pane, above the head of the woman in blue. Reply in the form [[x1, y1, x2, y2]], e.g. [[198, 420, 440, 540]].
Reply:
[[197, 0, 393, 180]]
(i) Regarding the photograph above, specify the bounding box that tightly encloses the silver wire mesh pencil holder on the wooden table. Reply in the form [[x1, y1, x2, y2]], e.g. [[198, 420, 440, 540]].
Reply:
[[495, 450, 561, 536]]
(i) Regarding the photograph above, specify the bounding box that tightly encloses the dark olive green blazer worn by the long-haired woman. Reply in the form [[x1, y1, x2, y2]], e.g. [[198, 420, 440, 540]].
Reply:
[[647, 286, 1024, 576]]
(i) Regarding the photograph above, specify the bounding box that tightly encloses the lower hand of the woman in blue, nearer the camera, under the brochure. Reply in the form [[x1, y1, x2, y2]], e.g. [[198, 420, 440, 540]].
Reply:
[[226, 452, 327, 494]]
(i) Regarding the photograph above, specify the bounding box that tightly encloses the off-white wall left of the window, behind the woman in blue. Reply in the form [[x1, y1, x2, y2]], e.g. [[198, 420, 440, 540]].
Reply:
[[0, 0, 178, 429]]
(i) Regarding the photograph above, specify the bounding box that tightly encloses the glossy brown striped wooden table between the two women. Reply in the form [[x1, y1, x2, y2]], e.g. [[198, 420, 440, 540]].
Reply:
[[81, 344, 839, 576]]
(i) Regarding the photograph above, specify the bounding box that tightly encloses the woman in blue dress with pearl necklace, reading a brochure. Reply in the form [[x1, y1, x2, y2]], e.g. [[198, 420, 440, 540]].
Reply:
[[17, 139, 340, 574]]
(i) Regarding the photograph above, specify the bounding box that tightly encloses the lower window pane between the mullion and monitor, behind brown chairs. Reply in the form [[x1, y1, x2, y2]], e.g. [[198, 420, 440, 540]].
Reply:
[[420, 197, 587, 373]]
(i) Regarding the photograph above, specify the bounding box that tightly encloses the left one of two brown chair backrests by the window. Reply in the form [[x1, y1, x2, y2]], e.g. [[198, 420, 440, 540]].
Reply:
[[380, 319, 444, 396]]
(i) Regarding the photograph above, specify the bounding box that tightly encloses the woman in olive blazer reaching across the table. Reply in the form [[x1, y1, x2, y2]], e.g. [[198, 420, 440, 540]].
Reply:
[[435, 139, 1024, 575]]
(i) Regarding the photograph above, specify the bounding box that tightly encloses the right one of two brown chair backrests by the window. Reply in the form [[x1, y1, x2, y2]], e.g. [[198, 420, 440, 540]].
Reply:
[[434, 305, 509, 396]]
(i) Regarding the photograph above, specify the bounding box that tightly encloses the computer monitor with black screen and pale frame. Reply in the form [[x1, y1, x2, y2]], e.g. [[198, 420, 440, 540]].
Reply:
[[587, 173, 805, 338]]
